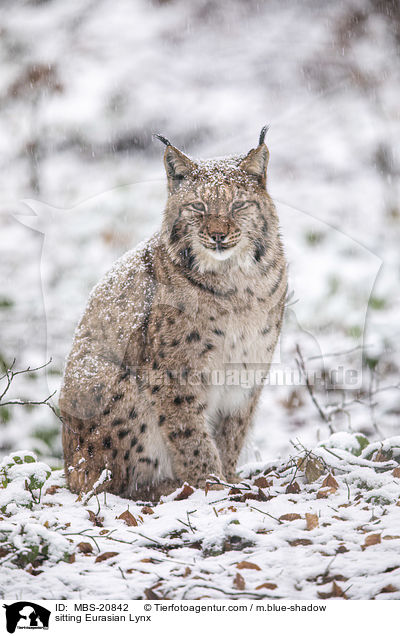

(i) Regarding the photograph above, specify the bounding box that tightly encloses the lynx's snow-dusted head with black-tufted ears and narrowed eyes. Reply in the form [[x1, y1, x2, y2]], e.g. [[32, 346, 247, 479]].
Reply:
[[156, 126, 278, 272]]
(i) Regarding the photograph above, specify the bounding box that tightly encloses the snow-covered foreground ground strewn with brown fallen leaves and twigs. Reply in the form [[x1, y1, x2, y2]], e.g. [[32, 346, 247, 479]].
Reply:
[[0, 432, 400, 599]]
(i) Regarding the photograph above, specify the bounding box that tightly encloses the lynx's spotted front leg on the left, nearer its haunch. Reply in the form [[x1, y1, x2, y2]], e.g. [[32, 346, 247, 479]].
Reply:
[[158, 386, 224, 488]]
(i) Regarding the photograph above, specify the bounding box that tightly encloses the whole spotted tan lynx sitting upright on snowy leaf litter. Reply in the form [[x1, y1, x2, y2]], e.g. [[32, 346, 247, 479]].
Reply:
[[60, 127, 287, 499]]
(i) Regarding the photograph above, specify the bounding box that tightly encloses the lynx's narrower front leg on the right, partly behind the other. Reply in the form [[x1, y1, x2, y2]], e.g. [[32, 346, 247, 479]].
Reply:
[[215, 387, 261, 482]]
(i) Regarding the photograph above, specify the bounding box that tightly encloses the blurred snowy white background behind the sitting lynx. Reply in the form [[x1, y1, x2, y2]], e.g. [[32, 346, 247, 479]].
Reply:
[[0, 0, 400, 466]]
